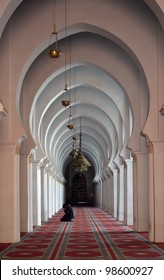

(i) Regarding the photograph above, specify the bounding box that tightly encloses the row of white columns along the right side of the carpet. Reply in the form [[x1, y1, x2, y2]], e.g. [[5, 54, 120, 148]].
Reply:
[[95, 158, 142, 228]]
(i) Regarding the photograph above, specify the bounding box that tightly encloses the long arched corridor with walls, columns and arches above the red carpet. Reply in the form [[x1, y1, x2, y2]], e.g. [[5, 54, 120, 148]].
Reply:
[[0, 0, 164, 256]]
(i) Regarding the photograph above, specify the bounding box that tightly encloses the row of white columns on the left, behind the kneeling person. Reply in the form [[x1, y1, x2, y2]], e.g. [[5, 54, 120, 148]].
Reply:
[[18, 149, 65, 234]]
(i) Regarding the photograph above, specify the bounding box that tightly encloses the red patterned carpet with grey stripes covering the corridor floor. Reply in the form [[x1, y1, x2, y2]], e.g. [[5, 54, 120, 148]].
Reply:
[[0, 207, 164, 260]]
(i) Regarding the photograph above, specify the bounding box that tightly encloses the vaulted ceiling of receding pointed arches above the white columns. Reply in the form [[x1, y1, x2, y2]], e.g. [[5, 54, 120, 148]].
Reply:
[[1, 0, 163, 180]]
